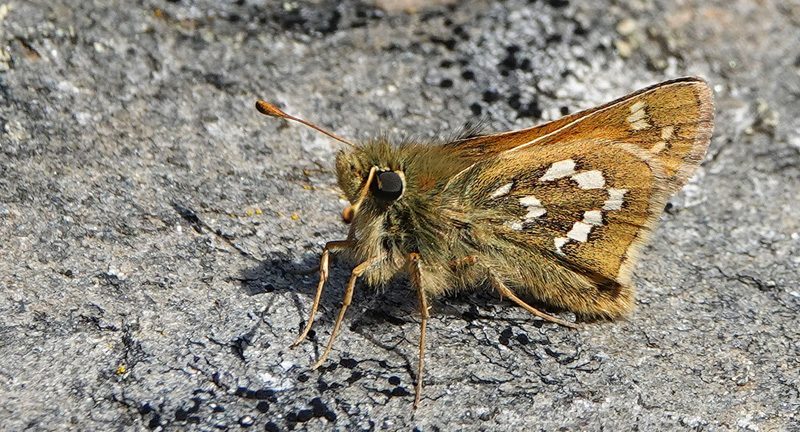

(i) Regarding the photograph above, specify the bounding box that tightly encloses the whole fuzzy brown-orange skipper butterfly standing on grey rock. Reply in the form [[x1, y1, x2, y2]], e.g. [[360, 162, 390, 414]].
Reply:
[[256, 77, 714, 408]]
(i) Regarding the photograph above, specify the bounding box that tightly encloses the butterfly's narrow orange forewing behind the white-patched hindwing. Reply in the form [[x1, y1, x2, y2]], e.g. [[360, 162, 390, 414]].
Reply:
[[447, 77, 714, 192]]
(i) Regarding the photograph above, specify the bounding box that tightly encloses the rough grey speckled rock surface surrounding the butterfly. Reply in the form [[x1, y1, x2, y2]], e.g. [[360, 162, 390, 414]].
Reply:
[[0, 0, 800, 431]]
